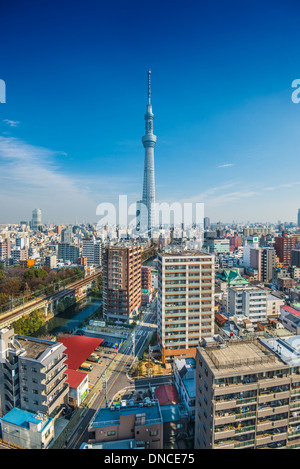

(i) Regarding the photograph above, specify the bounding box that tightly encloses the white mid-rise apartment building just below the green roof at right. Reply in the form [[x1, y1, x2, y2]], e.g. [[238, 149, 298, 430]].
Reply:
[[228, 286, 268, 324]]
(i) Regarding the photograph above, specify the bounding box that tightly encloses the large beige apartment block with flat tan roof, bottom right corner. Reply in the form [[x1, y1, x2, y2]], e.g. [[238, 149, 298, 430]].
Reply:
[[194, 336, 300, 449]]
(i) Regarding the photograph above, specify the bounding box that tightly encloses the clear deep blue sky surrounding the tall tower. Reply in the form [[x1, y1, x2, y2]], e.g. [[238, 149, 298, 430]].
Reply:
[[0, 0, 300, 223]]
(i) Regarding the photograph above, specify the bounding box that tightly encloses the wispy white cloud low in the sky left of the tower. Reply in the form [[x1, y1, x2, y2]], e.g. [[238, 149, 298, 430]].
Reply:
[[0, 136, 142, 223]]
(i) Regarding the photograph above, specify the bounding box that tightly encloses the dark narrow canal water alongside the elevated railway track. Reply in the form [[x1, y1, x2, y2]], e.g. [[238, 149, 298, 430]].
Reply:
[[32, 295, 102, 337]]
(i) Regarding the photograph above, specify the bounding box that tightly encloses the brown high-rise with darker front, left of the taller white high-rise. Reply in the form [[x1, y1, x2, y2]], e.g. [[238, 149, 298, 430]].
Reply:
[[103, 245, 141, 322]]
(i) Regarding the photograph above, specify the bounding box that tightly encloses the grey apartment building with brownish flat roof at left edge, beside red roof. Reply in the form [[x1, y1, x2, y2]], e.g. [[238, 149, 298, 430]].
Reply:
[[0, 329, 69, 416]]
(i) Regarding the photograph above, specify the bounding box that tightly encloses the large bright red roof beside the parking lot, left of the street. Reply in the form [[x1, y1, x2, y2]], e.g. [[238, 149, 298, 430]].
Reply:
[[58, 335, 103, 370]]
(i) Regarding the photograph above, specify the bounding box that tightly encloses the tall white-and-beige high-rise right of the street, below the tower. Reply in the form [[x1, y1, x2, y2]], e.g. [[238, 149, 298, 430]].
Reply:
[[157, 250, 215, 363]]
